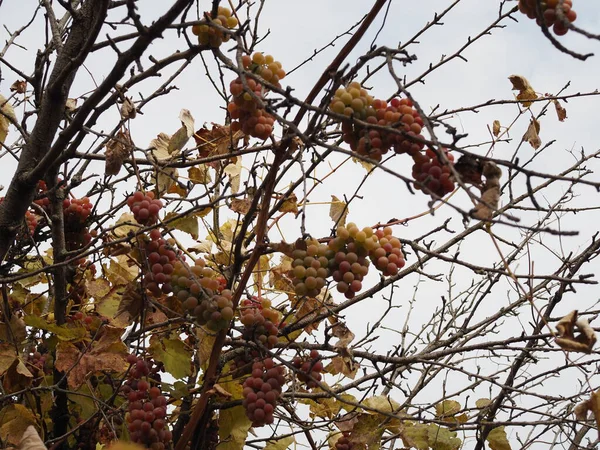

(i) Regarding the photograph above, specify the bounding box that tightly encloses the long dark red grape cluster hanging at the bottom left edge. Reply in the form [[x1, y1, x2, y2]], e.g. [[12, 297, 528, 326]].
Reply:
[[121, 355, 173, 450]]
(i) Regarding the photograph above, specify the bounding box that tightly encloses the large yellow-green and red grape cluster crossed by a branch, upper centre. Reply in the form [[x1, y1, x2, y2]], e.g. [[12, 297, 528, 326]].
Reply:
[[329, 81, 423, 161]]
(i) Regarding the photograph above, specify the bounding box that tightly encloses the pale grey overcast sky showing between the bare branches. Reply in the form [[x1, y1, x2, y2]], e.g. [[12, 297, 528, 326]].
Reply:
[[0, 0, 600, 448]]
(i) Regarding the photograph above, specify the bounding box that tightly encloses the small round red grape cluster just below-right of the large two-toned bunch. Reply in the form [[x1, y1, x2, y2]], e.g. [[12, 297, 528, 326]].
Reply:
[[412, 149, 454, 197]]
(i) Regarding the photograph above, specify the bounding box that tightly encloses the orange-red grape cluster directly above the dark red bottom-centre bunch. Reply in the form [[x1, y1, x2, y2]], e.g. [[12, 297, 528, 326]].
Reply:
[[240, 299, 280, 349]]
